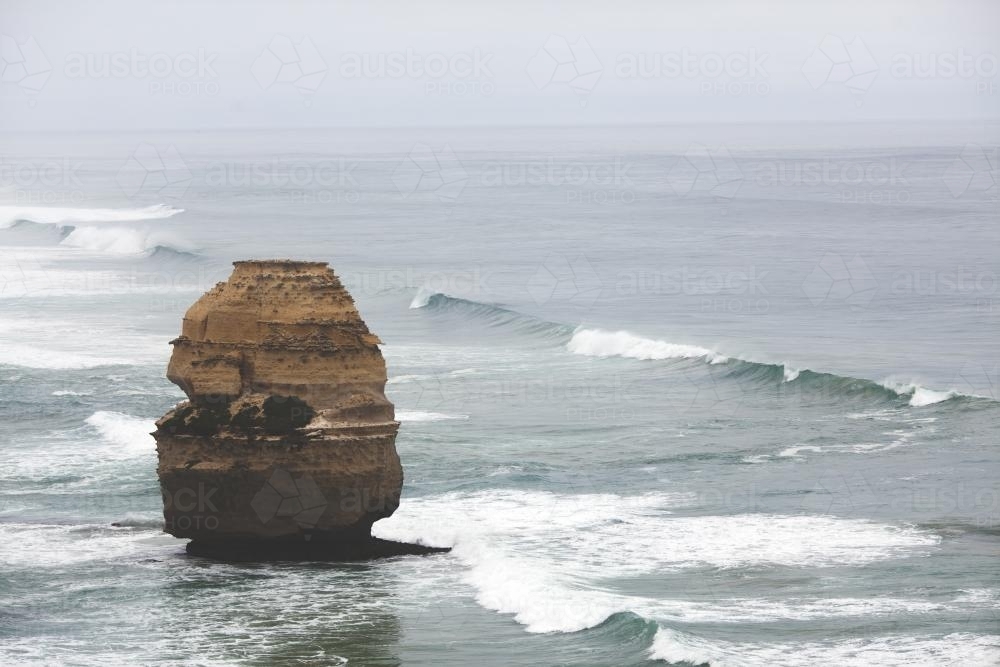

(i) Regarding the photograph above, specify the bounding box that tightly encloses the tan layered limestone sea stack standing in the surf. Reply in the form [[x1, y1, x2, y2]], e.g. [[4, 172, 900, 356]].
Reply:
[[153, 260, 442, 559]]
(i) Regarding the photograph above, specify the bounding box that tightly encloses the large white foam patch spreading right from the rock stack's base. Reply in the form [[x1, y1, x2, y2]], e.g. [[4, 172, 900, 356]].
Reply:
[[375, 489, 939, 632]]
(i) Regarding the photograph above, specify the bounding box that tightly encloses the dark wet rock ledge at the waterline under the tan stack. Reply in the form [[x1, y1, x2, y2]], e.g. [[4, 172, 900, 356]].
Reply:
[[187, 537, 451, 563]]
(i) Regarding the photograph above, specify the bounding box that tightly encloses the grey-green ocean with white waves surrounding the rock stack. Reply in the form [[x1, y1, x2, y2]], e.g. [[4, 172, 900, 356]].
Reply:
[[0, 126, 1000, 666]]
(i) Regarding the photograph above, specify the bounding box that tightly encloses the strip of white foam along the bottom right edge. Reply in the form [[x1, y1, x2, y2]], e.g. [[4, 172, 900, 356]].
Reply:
[[650, 628, 1000, 667]]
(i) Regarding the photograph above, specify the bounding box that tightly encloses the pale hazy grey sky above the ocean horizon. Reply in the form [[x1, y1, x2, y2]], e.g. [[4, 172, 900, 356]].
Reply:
[[0, 0, 1000, 130]]
